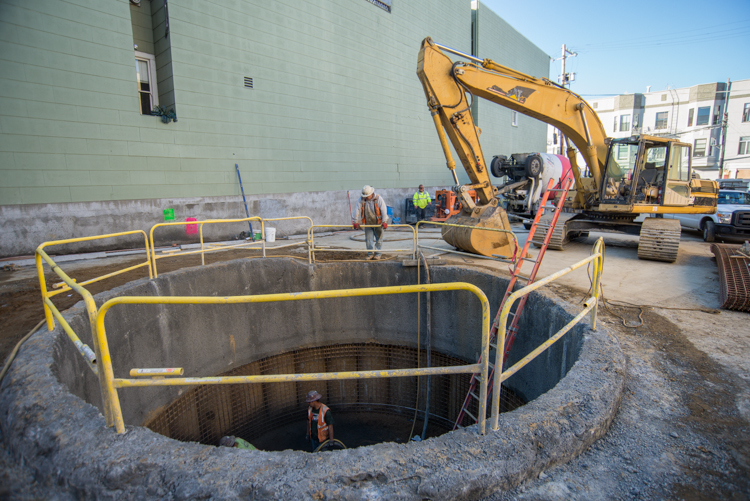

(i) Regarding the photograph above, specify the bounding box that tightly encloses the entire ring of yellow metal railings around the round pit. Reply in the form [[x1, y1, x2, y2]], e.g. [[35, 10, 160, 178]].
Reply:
[[35, 221, 604, 434]]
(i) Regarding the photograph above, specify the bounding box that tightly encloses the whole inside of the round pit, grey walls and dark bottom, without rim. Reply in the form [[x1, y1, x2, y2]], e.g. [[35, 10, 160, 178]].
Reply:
[[56, 258, 585, 450]]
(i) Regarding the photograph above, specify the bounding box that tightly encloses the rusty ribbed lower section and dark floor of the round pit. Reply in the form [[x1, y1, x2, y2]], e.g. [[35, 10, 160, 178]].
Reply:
[[145, 343, 523, 451]]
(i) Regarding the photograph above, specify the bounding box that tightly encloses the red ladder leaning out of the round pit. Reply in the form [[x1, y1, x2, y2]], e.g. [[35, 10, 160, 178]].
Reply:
[[453, 179, 573, 430]]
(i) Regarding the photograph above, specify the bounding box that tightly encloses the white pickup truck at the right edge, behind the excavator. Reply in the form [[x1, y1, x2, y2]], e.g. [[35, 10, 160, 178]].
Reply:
[[664, 190, 750, 242]]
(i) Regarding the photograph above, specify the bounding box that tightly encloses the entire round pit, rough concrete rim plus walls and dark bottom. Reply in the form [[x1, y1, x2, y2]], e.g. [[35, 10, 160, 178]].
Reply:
[[0, 258, 625, 499]]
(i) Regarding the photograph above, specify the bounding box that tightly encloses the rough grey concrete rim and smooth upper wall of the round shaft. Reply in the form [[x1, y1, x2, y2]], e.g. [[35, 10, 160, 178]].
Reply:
[[0, 259, 625, 499]]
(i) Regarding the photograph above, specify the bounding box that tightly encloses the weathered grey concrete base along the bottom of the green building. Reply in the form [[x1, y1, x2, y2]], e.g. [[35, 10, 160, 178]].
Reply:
[[0, 186, 445, 257]]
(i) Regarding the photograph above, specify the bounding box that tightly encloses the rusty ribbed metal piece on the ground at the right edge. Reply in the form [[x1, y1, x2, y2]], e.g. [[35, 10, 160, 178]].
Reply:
[[711, 244, 750, 311]]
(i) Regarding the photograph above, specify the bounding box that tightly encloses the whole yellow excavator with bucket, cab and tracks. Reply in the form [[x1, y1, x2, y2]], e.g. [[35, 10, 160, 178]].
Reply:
[[417, 38, 719, 262]]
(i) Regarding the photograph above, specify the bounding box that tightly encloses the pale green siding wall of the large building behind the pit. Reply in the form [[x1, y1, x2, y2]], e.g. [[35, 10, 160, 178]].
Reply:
[[0, 0, 547, 255]]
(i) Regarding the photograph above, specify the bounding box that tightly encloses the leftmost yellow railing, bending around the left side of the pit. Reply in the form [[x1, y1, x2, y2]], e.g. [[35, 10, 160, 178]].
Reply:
[[34, 230, 153, 411]]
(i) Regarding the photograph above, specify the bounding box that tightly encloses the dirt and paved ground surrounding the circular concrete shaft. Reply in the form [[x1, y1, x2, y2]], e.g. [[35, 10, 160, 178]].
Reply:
[[0, 232, 750, 501]]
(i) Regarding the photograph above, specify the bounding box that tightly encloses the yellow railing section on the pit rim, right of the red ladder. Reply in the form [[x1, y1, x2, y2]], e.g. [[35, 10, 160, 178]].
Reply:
[[491, 237, 604, 431]]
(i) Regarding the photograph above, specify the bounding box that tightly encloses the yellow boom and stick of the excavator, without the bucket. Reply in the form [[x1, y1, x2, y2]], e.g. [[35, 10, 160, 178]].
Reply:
[[417, 38, 607, 204]]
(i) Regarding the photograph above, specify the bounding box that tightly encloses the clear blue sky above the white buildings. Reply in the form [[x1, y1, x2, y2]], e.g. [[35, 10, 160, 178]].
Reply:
[[482, 0, 750, 97]]
